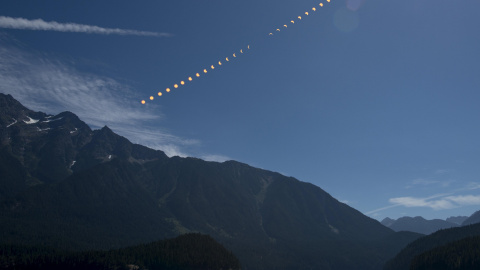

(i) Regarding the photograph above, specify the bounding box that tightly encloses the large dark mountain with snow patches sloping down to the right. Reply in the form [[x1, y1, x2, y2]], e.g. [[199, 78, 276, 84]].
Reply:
[[0, 94, 419, 269]]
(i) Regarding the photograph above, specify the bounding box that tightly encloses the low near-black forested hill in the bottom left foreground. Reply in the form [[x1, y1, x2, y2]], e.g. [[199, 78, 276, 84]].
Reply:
[[0, 234, 240, 270]]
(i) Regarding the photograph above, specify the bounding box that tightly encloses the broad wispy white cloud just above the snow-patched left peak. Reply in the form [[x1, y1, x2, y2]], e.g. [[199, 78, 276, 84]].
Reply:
[[0, 36, 200, 157]]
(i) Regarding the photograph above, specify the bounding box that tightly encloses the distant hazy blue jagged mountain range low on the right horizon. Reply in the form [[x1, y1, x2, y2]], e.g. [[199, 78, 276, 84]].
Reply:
[[381, 217, 459, 234]]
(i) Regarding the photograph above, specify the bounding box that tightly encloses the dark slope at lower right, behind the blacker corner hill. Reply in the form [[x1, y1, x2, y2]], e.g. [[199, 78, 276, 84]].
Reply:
[[384, 223, 480, 270]]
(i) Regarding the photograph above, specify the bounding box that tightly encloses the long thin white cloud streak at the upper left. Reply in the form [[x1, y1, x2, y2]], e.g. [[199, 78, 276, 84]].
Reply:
[[0, 16, 171, 37]]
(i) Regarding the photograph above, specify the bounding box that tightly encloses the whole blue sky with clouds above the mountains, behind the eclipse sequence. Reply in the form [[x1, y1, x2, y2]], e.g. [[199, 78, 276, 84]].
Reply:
[[0, 0, 480, 220]]
